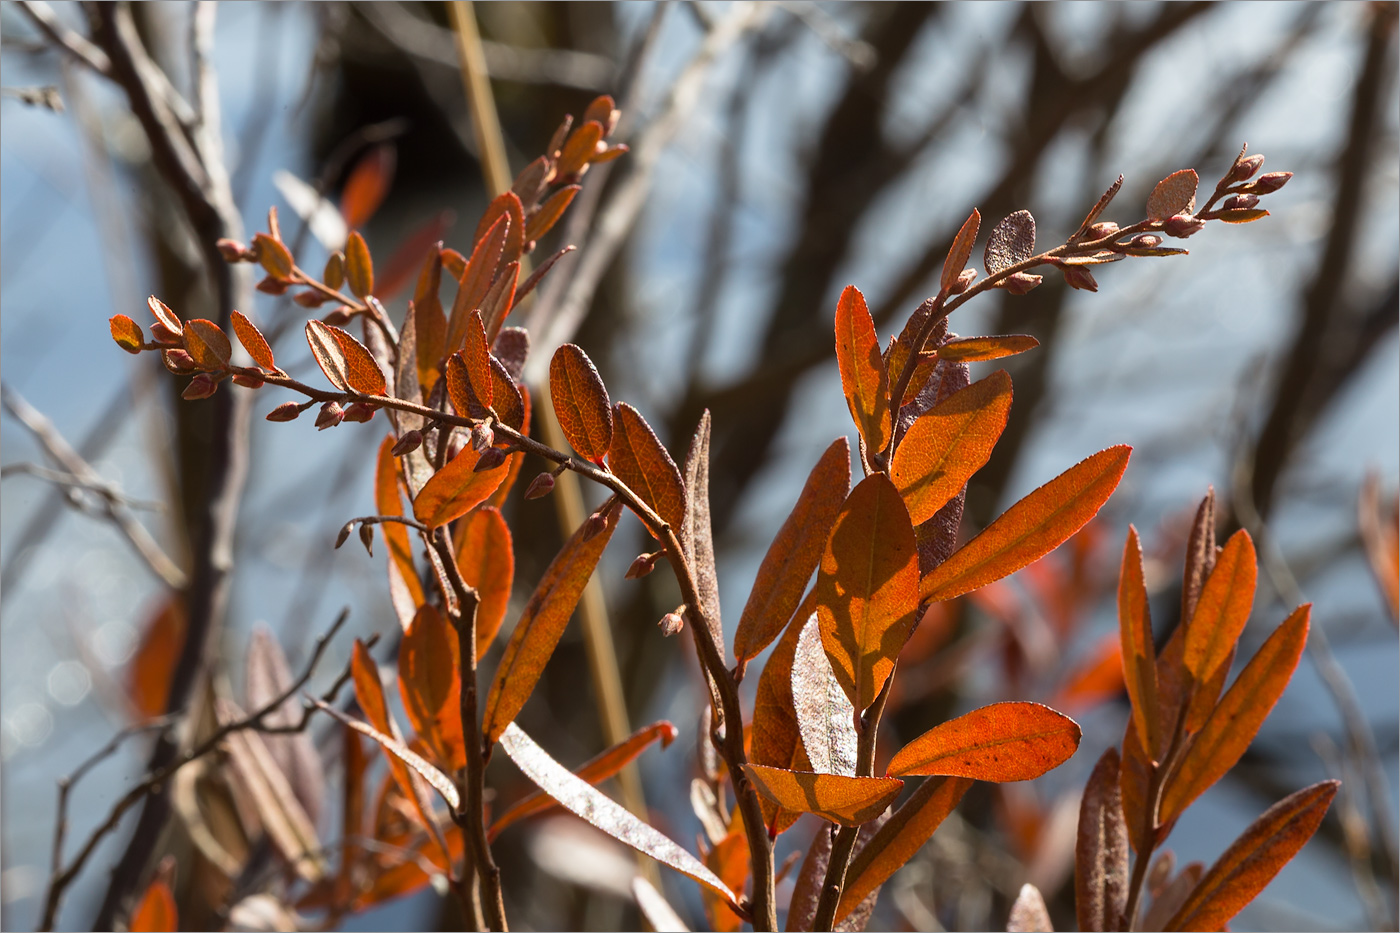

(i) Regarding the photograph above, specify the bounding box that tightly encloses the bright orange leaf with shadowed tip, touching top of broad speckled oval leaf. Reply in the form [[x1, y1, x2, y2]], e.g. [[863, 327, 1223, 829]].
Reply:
[[889, 370, 1011, 525]]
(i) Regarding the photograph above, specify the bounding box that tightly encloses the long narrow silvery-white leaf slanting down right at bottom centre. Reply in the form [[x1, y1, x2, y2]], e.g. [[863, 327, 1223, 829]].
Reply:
[[501, 723, 739, 906]]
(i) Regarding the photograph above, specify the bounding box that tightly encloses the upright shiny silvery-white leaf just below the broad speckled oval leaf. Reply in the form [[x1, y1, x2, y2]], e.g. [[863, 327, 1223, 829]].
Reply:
[[792, 612, 858, 778]]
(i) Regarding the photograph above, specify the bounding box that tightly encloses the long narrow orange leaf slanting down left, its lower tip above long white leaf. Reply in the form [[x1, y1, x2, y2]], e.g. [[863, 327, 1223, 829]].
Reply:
[[483, 502, 622, 745]]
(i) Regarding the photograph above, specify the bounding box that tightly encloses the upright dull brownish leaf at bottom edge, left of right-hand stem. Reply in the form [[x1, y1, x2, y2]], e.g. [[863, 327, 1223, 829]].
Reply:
[[1074, 748, 1128, 932]]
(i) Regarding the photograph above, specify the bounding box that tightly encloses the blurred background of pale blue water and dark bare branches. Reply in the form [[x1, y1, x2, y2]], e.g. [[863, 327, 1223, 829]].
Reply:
[[0, 1, 1400, 930]]
